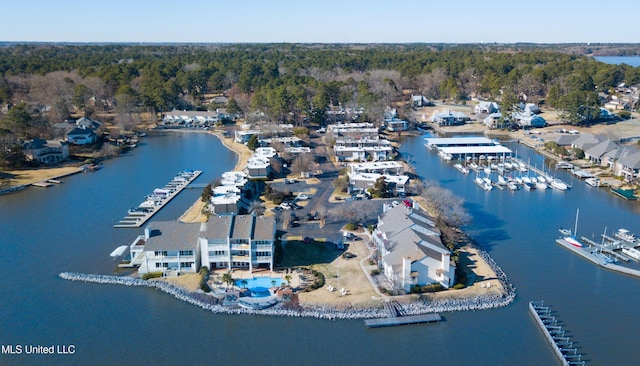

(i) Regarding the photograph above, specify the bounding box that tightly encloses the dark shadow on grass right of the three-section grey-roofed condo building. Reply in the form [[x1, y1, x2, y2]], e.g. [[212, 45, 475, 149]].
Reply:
[[278, 240, 343, 267]]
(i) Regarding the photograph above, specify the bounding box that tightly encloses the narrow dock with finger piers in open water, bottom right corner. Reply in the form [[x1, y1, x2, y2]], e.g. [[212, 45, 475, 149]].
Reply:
[[529, 301, 585, 365]]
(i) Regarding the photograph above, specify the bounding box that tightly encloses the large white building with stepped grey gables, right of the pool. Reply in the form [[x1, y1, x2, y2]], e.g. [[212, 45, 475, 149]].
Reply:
[[373, 204, 456, 292]]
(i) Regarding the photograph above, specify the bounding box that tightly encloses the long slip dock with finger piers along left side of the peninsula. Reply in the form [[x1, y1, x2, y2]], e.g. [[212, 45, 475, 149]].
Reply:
[[113, 170, 202, 228]]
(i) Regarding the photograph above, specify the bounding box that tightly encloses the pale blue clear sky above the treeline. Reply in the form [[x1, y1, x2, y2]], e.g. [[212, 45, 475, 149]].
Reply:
[[0, 0, 640, 43]]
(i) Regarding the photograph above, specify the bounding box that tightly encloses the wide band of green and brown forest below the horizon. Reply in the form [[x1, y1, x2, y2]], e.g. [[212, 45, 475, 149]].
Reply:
[[0, 44, 640, 154]]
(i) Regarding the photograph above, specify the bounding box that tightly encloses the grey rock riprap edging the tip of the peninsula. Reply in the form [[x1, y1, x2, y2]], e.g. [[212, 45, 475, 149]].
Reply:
[[59, 240, 516, 320]]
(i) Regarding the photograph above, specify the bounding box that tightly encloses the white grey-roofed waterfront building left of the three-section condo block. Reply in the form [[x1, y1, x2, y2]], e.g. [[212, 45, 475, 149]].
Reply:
[[137, 221, 200, 275]]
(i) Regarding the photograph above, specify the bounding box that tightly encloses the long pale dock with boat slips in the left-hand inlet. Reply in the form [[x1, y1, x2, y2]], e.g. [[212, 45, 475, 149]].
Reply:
[[113, 170, 202, 228]]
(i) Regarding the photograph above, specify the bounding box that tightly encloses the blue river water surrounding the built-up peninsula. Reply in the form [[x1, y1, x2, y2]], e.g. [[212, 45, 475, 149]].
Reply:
[[0, 134, 640, 365]]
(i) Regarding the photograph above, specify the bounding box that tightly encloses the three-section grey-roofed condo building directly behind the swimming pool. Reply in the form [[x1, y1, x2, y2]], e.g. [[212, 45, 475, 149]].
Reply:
[[199, 215, 276, 271]]
